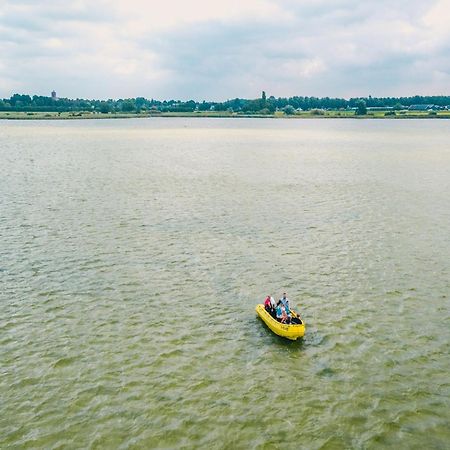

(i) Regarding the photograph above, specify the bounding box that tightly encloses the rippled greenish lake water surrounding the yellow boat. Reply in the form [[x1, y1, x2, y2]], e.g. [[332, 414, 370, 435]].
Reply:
[[0, 118, 450, 449]]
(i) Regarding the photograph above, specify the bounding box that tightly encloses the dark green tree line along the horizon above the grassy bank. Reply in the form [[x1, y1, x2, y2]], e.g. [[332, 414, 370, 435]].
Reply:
[[0, 92, 450, 114]]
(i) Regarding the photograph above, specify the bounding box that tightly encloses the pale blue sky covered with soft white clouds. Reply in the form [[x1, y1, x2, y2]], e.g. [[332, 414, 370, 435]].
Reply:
[[0, 0, 450, 101]]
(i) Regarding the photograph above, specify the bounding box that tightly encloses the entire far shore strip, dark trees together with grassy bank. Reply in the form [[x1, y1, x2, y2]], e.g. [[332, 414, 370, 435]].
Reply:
[[0, 91, 450, 119]]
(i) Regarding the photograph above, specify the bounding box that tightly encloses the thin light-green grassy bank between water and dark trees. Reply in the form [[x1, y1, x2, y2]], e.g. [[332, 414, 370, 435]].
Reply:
[[0, 110, 450, 120]]
